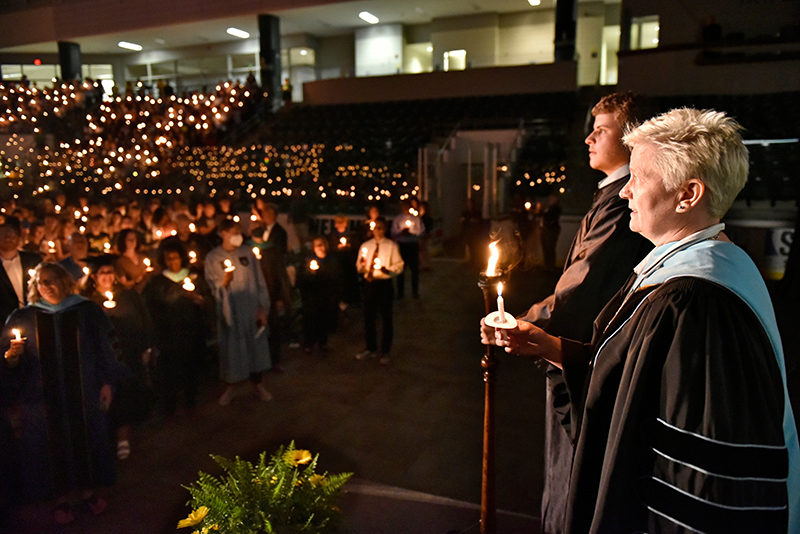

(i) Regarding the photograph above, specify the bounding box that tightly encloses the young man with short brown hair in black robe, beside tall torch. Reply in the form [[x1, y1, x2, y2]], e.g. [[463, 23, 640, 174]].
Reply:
[[520, 93, 652, 534]]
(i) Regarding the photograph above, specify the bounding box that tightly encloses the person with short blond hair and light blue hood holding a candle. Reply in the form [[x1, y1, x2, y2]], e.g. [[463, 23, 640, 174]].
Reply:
[[481, 109, 800, 534]]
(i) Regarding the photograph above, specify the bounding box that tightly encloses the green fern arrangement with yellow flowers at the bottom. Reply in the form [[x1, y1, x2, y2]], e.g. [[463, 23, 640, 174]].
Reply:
[[178, 441, 353, 534]]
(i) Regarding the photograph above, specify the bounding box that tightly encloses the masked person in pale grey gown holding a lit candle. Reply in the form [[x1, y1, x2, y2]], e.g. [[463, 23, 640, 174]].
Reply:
[[205, 219, 272, 406]]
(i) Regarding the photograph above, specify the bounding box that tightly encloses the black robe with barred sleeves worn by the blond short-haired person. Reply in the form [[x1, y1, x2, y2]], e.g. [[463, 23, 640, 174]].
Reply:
[[562, 277, 788, 534]]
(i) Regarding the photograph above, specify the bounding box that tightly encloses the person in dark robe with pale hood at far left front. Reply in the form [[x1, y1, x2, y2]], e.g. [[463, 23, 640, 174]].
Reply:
[[0, 262, 124, 523]]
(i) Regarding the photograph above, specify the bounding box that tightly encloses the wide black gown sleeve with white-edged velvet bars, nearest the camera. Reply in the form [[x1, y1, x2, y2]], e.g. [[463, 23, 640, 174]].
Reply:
[[596, 278, 789, 534]]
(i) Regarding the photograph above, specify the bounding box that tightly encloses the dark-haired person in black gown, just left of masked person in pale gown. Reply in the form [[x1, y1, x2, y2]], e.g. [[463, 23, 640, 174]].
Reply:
[[142, 241, 214, 417]]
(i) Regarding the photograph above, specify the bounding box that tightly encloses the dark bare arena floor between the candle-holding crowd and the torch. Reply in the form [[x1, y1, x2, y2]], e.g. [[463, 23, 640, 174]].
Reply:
[[4, 248, 797, 534]]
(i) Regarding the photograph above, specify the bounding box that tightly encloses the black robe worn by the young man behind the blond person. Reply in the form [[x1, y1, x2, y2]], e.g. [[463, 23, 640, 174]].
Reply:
[[520, 176, 653, 534]]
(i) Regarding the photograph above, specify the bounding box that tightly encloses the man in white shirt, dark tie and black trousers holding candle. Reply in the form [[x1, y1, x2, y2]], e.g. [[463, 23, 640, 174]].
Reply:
[[356, 217, 404, 365]]
